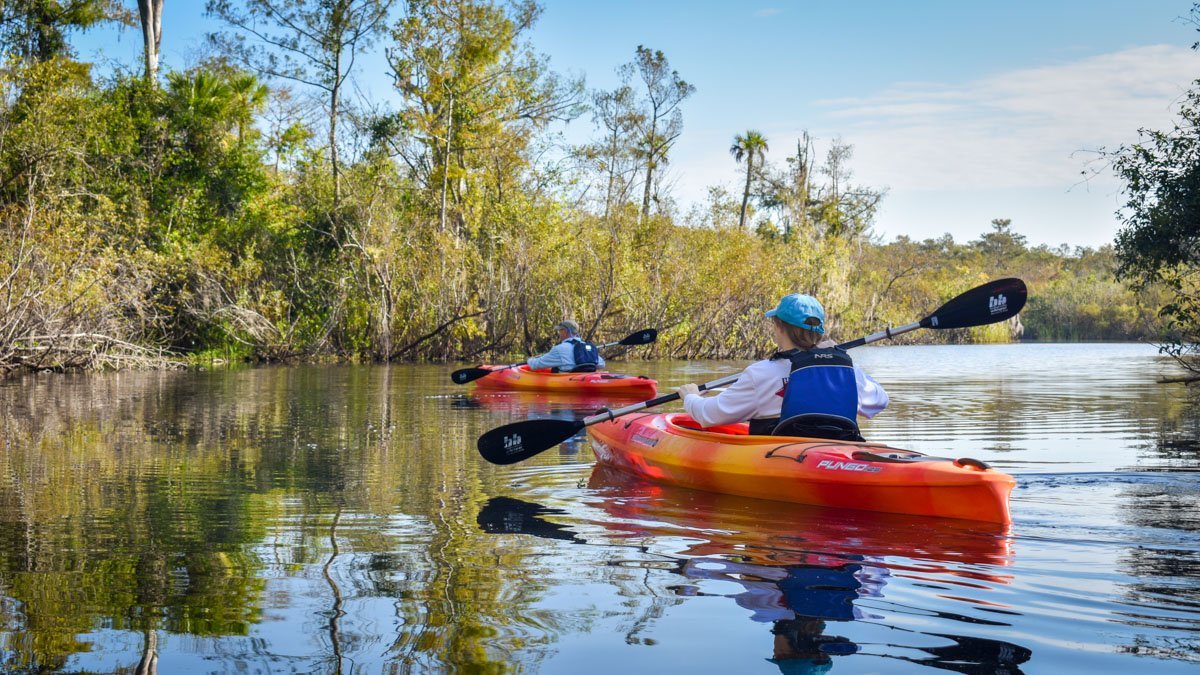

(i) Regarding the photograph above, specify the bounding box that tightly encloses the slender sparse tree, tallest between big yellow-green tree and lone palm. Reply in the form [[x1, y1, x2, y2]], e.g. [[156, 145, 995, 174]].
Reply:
[[622, 44, 696, 217]]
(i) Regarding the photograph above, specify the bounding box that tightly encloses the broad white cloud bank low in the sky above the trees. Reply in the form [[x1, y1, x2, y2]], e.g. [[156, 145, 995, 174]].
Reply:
[[668, 46, 1200, 246]]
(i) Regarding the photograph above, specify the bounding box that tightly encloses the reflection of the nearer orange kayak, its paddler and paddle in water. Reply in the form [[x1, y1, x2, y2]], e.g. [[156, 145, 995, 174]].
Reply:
[[476, 467, 1031, 674]]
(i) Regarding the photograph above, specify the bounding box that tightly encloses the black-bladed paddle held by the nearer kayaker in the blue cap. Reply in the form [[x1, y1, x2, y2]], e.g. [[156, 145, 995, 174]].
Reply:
[[475, 279, 1028, 464]]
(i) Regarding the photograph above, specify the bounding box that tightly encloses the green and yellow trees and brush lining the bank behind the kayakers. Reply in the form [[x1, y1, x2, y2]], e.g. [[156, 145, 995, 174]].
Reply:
[[0, 0, 1159, 371]]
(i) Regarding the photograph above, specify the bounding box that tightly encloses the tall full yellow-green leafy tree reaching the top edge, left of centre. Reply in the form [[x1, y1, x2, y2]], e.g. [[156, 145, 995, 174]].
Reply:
[[386, 0, 583, 234]]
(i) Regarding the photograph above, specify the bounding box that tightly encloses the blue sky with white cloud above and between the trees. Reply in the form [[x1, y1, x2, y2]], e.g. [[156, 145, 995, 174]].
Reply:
[[73, 0, 1200, 247]]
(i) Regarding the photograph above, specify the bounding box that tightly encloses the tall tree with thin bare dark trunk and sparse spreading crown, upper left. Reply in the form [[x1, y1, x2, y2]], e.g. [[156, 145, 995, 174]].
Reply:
[[206, 0, 392, 230]]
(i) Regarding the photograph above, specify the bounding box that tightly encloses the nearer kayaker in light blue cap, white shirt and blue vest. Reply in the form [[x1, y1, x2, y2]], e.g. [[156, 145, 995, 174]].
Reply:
[[678, 293, 888, 435]]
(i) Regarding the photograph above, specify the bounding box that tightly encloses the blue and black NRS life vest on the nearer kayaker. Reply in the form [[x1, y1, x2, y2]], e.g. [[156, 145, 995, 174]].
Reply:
[[772, 347, 858, 422]]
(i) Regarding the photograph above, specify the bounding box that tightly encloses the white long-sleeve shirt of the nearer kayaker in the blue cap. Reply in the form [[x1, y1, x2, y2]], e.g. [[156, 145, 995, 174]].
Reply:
[[683, 359, 888, 426]]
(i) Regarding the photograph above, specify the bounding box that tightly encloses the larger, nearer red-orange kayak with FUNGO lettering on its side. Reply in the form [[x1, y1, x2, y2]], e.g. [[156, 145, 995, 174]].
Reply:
[[588, 413, 1016, 524]]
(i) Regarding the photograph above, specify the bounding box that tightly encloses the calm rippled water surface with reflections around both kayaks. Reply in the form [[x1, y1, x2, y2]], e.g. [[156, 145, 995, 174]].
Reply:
[[0, 345, 1200, 674]]
